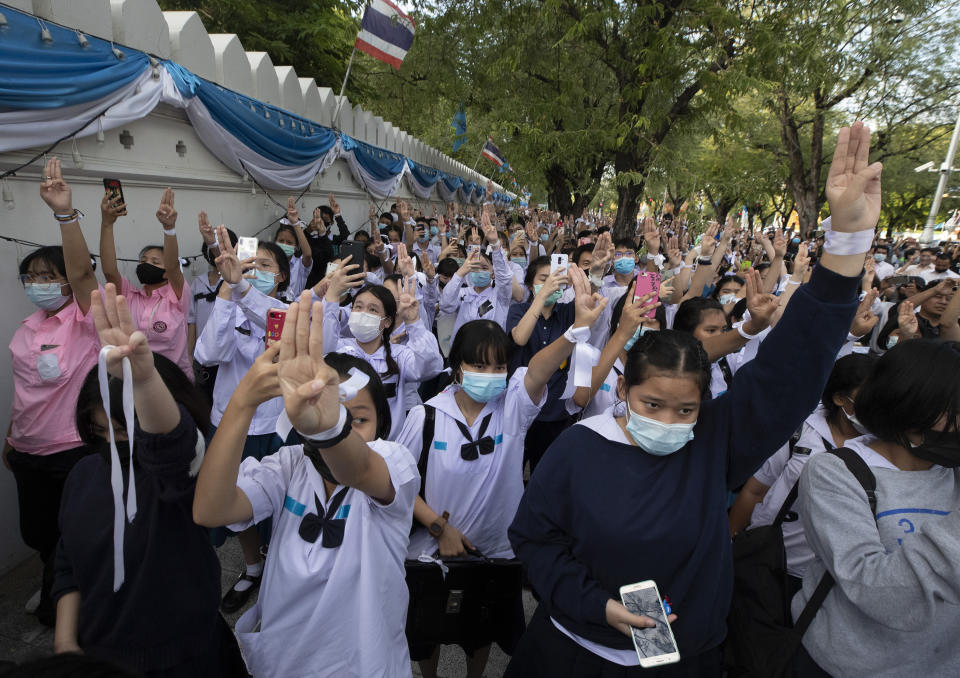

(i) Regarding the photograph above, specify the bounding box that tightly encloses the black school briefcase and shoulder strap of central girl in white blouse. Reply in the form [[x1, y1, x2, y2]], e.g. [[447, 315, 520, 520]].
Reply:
[[405, 404, 524, 654]]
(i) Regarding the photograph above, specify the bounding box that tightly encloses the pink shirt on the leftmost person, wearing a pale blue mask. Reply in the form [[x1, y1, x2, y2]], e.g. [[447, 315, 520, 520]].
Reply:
[[7, 302, 100, 456]]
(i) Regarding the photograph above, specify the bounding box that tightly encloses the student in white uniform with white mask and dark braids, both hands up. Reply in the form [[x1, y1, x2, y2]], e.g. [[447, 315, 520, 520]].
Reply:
[[323, 278, 443, 440]]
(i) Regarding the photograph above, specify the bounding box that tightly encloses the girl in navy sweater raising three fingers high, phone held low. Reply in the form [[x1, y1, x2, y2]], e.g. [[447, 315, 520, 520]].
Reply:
[[506, 122, 881, 678]]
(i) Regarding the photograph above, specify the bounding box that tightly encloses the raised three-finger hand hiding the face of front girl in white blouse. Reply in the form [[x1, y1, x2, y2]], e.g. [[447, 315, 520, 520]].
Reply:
[[277, 290, 340, 435]]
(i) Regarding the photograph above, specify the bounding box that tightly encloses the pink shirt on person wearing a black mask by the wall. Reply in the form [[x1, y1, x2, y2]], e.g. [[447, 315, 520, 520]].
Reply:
[[121, 276, 193, 381]]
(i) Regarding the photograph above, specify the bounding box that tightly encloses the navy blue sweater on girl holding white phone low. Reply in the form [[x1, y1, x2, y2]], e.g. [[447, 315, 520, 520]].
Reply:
[[509, 268, 859, 656]]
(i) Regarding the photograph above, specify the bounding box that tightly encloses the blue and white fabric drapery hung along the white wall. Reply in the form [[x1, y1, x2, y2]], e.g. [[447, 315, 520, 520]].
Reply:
[[0, 6, 503, 203]]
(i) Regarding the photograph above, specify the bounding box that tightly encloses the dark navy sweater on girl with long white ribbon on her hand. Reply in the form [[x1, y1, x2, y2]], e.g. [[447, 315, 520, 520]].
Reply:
[[52, 406, 220, 672]]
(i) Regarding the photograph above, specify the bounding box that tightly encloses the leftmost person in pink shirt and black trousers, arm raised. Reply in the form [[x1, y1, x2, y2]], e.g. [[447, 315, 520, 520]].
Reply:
[[3, 158, 103, 626]]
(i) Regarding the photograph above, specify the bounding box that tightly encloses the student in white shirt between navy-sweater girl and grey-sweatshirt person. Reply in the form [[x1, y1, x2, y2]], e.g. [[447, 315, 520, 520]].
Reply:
[[729, 353, 876, 595]]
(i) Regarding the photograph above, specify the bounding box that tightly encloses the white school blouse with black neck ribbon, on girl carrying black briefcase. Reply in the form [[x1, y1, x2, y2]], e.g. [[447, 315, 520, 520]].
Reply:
[[397, 367, 547, 559]]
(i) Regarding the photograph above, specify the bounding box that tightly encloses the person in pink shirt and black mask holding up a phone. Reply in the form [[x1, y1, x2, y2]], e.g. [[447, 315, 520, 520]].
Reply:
[[100, 188, 193, 380]]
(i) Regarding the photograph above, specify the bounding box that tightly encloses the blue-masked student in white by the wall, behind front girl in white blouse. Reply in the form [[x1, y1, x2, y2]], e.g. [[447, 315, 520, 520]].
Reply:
[[194, 226, 289, 614]]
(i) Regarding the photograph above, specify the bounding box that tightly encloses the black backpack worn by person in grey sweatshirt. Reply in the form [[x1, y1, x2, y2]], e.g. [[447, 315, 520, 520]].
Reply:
[[724, 447, 877, 678]]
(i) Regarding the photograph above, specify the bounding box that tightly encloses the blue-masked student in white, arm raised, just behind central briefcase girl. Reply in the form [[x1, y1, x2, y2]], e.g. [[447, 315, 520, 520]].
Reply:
[[440, 211, 513, 336]]
